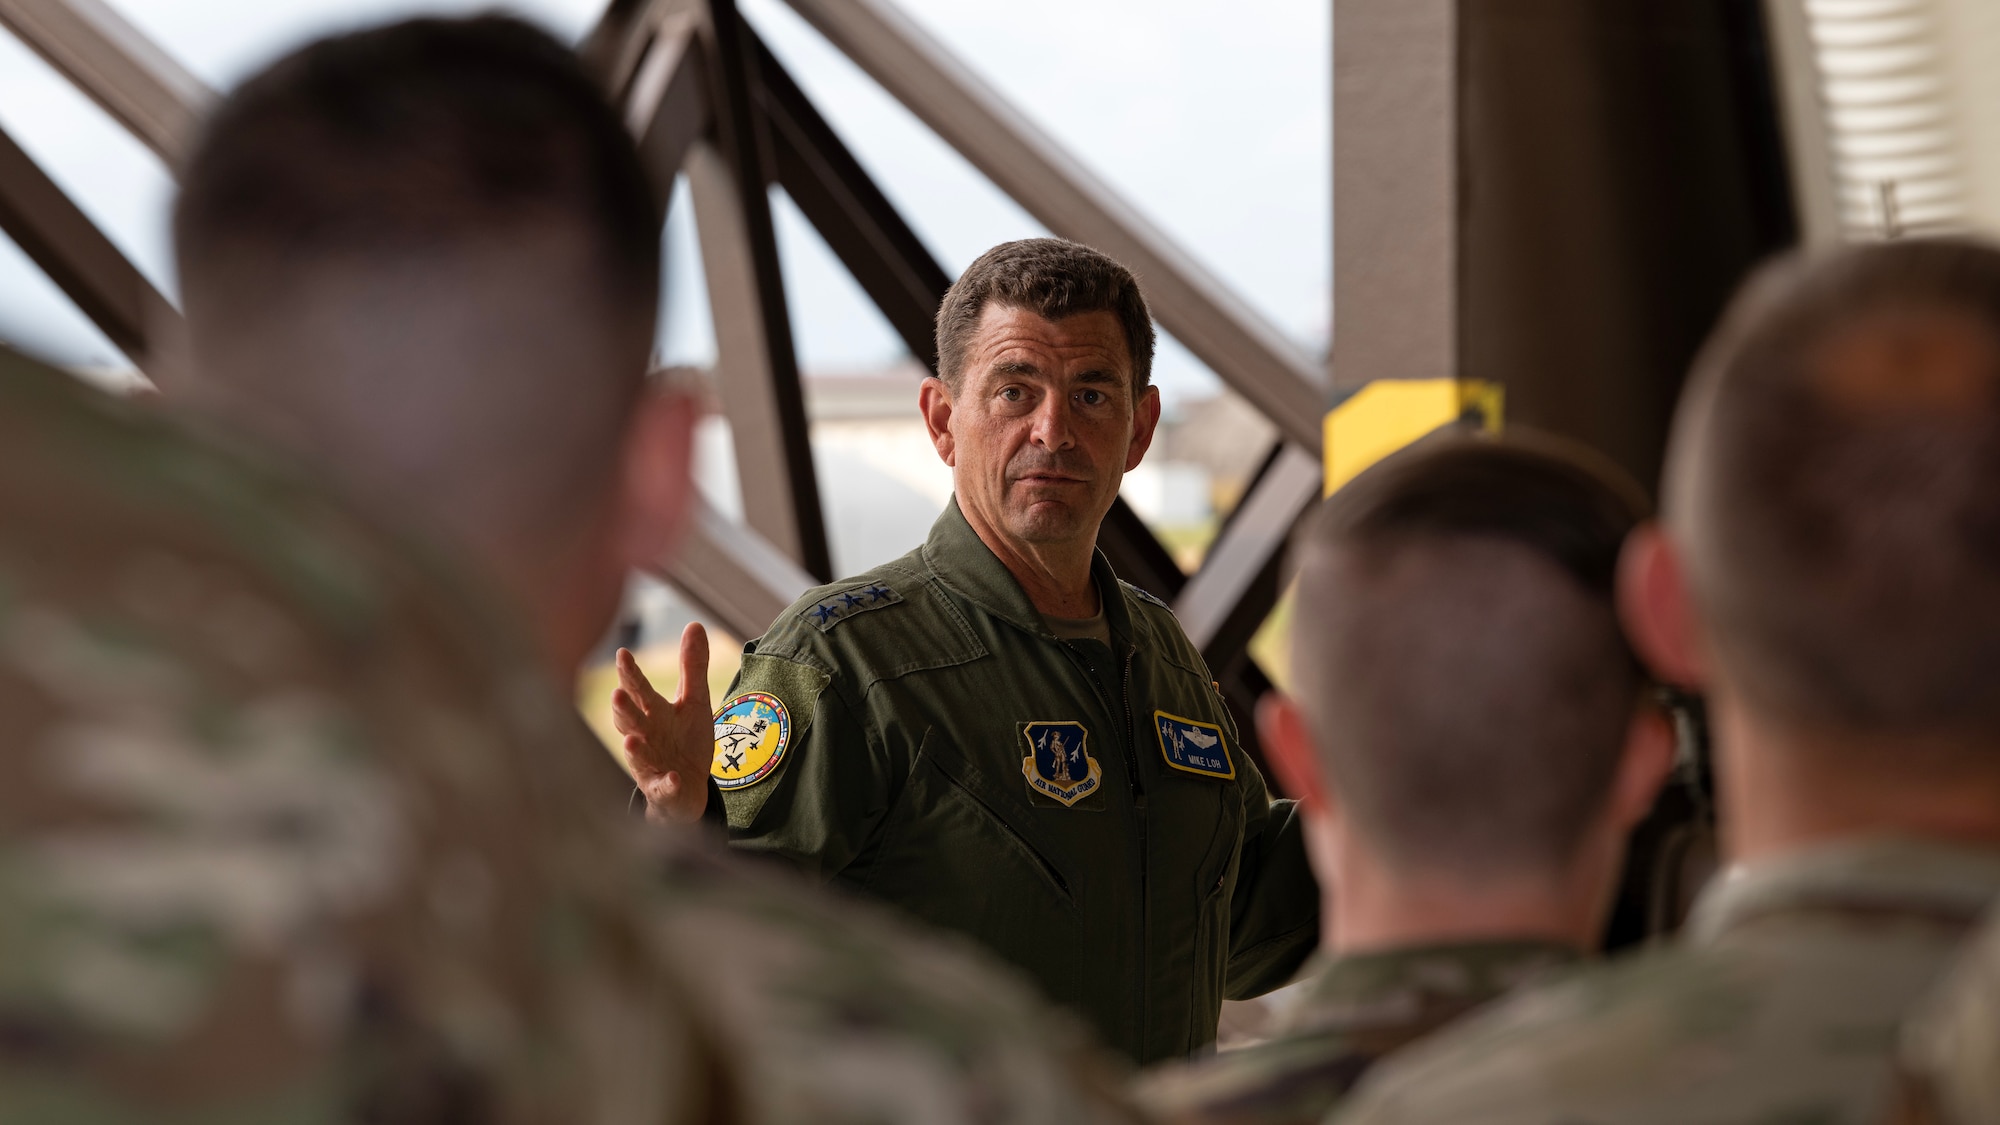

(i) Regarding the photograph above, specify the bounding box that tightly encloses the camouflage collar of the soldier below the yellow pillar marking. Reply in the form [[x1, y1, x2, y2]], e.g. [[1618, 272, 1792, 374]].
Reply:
[[1278, 939, 1580, 1035]]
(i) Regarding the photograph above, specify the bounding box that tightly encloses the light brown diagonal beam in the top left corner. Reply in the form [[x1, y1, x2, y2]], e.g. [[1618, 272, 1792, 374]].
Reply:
[[0, 0, 216, 170]]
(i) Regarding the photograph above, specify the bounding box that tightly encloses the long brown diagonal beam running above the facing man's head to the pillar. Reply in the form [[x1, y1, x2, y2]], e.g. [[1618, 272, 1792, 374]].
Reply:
[[786, 0, 1326, 452]]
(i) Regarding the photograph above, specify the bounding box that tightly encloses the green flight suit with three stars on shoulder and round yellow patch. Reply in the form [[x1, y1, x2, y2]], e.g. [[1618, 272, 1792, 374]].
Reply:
[[712, 500, 1320, 1063]]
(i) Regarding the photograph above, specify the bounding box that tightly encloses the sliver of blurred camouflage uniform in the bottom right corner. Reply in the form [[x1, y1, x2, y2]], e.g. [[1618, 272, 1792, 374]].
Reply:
[[1902, 900, 2000, 1125]]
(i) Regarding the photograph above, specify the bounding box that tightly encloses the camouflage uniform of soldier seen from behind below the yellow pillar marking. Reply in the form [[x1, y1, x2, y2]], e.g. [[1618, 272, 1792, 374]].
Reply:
[[1136, 941, 1576, 1125]]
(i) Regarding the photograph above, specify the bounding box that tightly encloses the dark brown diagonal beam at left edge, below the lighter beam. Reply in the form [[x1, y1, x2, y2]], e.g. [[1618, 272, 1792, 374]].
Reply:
[[0, 122, 180, 374]]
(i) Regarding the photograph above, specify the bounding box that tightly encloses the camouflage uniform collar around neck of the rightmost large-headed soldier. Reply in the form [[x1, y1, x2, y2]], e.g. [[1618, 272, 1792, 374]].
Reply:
[[1686, 837, 2000, 945]]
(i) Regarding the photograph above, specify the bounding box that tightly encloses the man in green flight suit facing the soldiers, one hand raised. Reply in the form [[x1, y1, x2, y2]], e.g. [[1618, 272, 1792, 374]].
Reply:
[[614, 238, 1320, 1063]]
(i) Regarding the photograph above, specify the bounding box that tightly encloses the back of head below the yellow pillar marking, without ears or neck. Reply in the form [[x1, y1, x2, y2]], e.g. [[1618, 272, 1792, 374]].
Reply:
[[1292, 434, 1646, 877]]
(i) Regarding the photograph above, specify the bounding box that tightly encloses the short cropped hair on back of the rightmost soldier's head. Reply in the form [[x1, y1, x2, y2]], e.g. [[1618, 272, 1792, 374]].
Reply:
[[1666, 240, 2000, 743]]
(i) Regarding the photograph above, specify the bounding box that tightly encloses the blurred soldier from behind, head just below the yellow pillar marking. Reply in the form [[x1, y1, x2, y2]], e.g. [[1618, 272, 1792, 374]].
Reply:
[[1140, 436, 1674, 1125]]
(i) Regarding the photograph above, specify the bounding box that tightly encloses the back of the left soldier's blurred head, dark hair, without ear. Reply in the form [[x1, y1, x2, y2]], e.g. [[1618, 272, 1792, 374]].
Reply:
[[174, 16, 660, 546]]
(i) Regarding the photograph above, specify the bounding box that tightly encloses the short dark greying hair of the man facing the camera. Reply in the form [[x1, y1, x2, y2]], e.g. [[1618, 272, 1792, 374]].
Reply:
[[938, 238, 1154, 394]]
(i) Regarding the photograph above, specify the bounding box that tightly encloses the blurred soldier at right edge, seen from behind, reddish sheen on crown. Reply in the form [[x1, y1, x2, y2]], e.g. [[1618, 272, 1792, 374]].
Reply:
[[1348, 242, 2000, 1125]]
